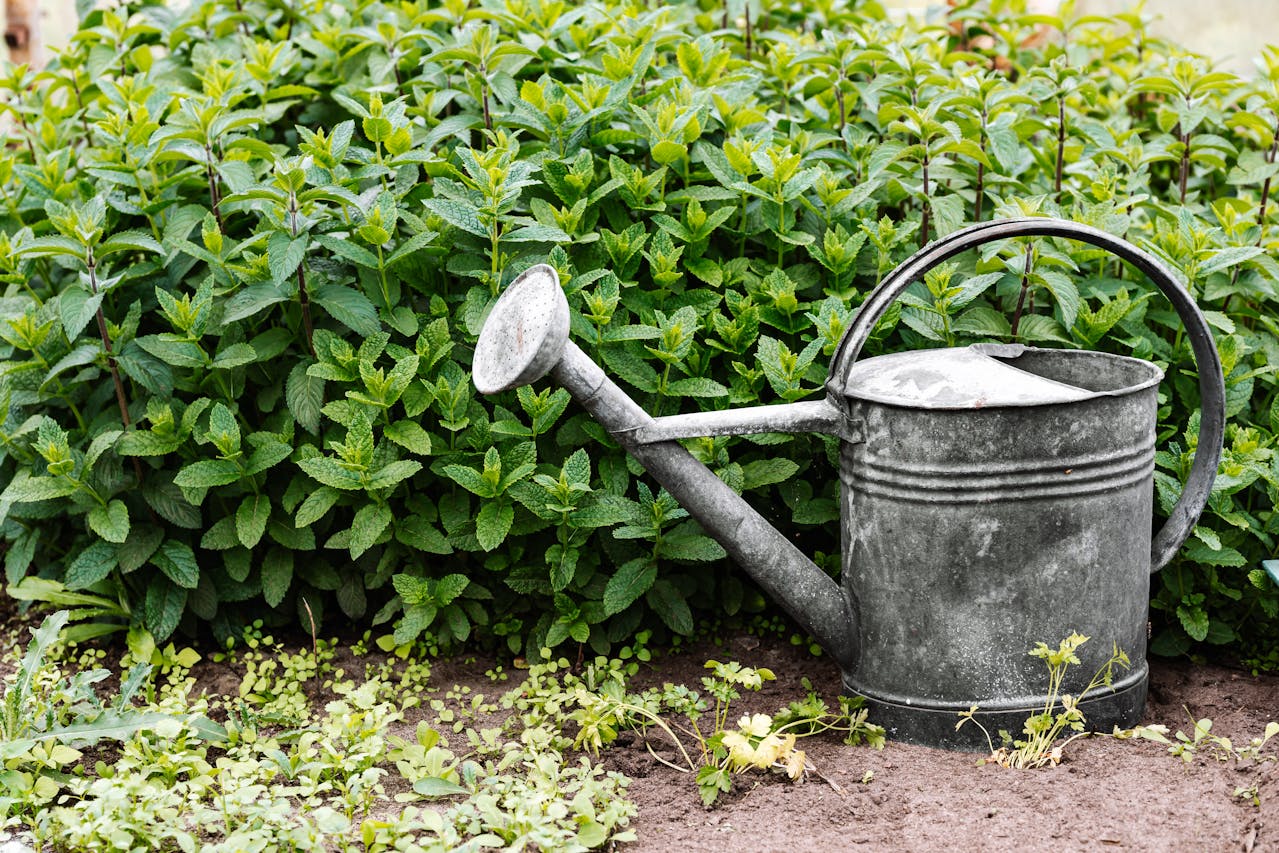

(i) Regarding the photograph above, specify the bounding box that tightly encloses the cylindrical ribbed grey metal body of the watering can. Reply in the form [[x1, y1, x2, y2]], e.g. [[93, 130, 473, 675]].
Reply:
[[840, 344, 1163, 746]]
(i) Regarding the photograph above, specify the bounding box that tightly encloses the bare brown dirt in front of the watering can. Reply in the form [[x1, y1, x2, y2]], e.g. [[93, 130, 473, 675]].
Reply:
[[604, 626, 1279, 853]]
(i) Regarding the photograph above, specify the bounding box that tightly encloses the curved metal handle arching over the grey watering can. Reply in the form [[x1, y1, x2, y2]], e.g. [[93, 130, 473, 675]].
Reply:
[[826, 219, 1225, 572]]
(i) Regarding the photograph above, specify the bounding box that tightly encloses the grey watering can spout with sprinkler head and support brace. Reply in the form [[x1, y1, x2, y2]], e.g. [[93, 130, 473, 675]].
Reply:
[[472, 265, 858, 668]]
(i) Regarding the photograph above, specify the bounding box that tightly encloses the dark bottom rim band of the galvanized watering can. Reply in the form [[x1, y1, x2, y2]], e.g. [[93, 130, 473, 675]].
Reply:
[[843, 662, 1150, 752]]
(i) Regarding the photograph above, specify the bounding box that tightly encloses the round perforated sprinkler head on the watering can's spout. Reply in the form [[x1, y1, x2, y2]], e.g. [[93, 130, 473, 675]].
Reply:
[[471, 263, 568, 394]]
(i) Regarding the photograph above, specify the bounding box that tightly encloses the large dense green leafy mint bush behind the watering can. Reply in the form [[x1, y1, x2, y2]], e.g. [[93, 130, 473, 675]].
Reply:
[[0, 0, 1279, 665]]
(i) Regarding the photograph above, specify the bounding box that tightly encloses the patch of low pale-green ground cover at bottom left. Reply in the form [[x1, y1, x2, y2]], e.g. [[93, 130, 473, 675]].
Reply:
[[0, 611, 634, 853]]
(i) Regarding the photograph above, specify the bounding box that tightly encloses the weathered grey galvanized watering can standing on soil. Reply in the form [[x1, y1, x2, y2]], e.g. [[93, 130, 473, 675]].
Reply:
[[473, 219, 1225, 749]]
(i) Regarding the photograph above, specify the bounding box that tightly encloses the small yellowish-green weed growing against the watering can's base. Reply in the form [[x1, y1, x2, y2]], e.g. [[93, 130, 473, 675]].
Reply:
[[955, 632, 1131, 770]]
